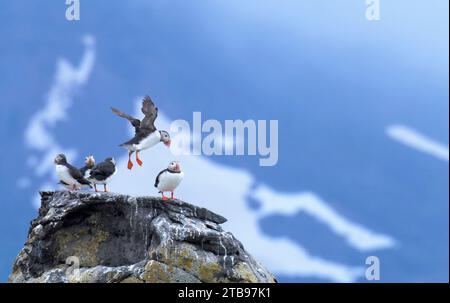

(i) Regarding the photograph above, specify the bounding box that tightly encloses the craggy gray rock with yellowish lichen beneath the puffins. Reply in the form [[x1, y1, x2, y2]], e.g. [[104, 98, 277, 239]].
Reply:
[[9, 191, 276, 283]]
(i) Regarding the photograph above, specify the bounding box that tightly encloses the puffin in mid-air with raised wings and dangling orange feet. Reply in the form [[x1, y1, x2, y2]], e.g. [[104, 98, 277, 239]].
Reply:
[[111, 96, 170, 169]]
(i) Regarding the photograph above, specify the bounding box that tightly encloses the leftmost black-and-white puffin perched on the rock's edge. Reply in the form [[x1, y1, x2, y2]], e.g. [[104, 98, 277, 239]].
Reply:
[[55, 154, 92, 190]]
